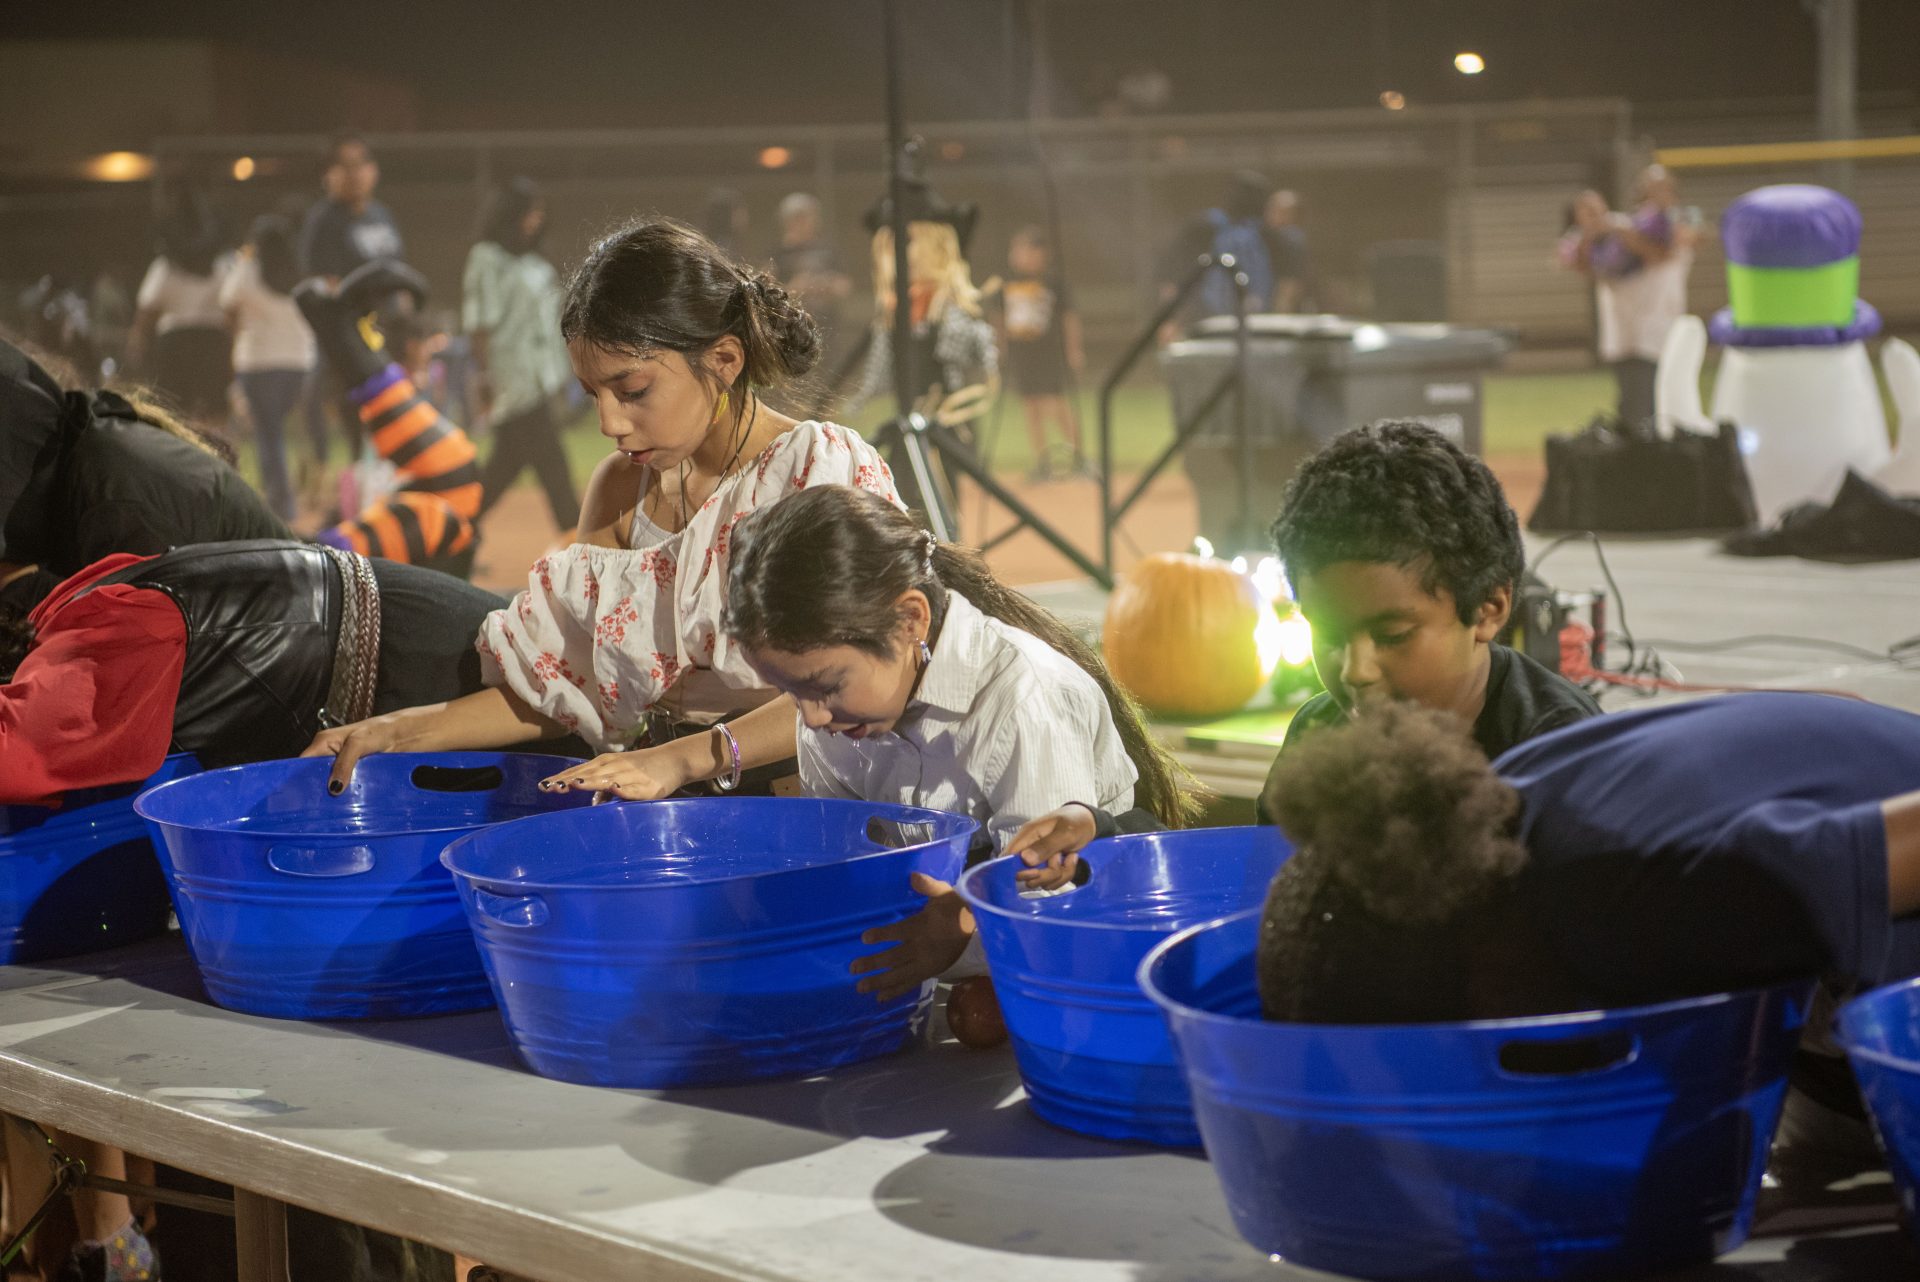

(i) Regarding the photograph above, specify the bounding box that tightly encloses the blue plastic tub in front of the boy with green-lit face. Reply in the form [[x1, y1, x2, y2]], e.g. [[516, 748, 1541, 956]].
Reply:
[[960, 827, 1292, 1146]]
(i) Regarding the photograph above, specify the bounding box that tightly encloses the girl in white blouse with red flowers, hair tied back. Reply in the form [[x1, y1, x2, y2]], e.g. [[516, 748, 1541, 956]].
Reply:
[[307, 217, 899, 800]]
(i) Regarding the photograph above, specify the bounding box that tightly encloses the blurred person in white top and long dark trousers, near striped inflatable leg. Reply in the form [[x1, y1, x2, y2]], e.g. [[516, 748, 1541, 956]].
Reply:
[[219, 213, 315, 520]]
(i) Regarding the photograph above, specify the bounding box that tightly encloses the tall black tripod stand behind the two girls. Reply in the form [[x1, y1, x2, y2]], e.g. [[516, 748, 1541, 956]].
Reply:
[[876, 0, 1114, 587]]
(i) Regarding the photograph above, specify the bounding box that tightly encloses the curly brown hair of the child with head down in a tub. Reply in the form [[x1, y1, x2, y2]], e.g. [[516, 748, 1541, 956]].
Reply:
[[1258, 700, 1592, 1023]]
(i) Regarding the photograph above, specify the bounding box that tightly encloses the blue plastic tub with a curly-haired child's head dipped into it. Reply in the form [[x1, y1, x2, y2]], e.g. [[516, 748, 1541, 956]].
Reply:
[[1140, 910, 1812, 1280]]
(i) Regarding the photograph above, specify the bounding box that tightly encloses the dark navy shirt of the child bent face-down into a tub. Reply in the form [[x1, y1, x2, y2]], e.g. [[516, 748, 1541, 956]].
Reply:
[[1494, 693, 1920, 1000]]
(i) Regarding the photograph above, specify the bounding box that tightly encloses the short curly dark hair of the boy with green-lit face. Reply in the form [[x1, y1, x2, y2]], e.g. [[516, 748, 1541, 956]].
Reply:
[[1273, 418, 1524, 624]]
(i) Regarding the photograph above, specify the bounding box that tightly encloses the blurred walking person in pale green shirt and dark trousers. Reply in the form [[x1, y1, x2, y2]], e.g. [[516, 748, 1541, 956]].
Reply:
[[461, 178, 580, 539]]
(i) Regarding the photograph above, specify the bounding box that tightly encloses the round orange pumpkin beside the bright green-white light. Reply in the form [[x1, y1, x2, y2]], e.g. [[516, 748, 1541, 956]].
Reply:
[[1100, 553, 1273, 718]]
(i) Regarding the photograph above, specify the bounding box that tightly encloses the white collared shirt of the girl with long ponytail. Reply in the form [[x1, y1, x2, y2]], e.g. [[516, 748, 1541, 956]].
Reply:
[[799, 593, 1139, 850]]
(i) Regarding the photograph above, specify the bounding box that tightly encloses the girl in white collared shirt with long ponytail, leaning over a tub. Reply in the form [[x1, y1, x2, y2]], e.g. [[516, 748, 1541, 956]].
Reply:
[[726, 486, 1196, 1002]]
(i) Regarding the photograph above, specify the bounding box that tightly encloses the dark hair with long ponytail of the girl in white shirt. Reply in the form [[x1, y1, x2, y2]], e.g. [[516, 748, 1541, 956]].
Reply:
[[726, 486, 1204, 827]]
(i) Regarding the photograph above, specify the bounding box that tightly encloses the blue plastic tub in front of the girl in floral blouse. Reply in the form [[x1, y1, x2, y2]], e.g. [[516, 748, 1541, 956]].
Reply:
[[138, 752, 591, 1019]]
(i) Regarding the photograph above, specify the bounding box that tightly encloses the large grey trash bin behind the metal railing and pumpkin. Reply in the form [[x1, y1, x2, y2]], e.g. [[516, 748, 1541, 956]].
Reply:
[[1160, 315, 1511, 555]]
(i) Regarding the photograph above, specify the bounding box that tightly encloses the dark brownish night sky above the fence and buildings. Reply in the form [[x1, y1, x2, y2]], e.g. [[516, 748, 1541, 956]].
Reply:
[[8, 0, 1920, 137]]
